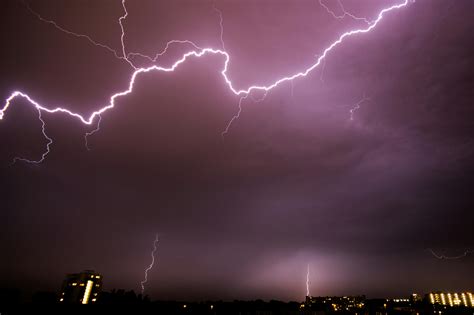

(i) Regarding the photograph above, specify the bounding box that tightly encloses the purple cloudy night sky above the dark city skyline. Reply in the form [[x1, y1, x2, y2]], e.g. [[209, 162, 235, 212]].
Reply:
[[0, 0, 474, 300]]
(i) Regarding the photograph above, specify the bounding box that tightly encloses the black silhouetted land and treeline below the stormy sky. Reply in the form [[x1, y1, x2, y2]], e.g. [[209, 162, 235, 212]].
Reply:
[[0, 289, 474, 315]]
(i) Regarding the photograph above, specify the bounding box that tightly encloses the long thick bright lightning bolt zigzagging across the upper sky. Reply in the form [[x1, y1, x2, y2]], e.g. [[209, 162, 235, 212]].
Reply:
[[0, 0, 410, 161]]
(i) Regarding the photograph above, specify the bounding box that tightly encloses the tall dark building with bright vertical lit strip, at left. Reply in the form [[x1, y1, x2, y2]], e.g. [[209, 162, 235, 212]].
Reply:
[[59, 270, 102, 304]]
